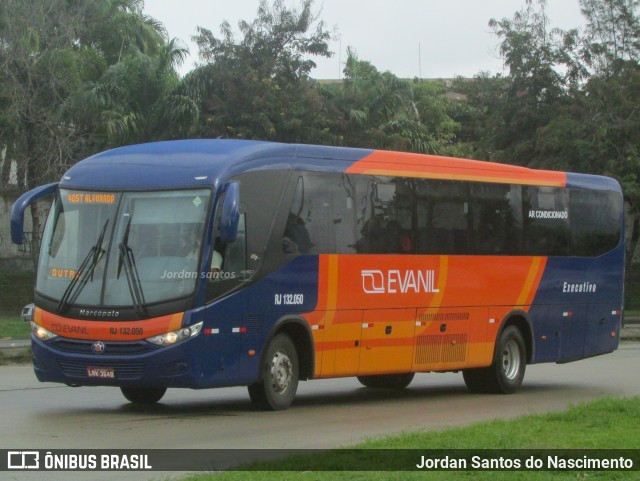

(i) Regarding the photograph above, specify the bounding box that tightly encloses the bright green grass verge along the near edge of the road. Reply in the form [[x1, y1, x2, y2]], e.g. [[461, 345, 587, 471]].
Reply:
[[178, 397, 640, 481]]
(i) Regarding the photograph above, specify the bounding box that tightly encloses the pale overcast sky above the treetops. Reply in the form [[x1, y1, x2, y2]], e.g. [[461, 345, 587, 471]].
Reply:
[[144, 0, 585, 79]]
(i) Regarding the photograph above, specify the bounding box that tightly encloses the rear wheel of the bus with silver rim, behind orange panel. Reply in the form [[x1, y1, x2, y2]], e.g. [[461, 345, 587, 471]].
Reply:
[[462, 326, 527, 394]]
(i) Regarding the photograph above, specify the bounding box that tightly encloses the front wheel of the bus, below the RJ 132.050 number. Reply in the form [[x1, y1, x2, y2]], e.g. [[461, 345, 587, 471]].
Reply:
[[248, 333, 300, 411]]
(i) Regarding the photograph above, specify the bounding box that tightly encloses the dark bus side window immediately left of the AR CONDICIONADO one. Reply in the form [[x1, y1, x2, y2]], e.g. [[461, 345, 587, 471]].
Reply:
[[471, 183, 522, 255]]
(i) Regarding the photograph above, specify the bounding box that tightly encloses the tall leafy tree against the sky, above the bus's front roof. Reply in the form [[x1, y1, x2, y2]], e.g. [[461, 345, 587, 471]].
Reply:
[[185, 0, 331, 143]]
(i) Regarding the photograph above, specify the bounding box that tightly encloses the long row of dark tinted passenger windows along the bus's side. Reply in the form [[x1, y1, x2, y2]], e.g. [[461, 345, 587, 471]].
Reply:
[[282, 173, 621, 256]]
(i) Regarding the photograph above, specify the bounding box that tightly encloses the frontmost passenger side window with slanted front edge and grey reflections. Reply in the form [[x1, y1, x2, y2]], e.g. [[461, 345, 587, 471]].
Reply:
[[282, 172, 355, 254]]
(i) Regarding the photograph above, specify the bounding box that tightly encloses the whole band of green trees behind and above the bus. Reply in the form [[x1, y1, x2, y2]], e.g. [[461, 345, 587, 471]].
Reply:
[[0, 0, 640, 251]]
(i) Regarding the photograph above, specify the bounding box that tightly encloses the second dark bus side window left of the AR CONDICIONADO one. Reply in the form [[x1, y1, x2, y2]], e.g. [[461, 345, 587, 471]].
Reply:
[[416, 180, 472, 255]]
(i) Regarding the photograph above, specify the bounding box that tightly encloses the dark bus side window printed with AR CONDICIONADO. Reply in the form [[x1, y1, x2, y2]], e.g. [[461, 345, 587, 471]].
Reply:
[[522, 187, 570, 256]]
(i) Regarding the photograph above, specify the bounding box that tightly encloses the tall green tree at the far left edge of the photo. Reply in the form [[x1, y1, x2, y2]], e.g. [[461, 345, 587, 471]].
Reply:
[[0, 0, 90, 187]]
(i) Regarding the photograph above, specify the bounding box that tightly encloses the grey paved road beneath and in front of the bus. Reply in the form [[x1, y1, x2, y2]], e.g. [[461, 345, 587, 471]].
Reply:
[[0, 343, 640, 481]]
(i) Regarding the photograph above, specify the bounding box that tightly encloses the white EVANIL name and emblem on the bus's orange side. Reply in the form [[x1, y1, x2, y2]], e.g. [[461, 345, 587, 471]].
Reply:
[[361, 269, 440, 294]]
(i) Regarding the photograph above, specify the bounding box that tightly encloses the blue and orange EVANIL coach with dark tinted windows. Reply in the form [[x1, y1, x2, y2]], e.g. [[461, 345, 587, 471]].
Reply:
[[11, 140, 625, 410]]
